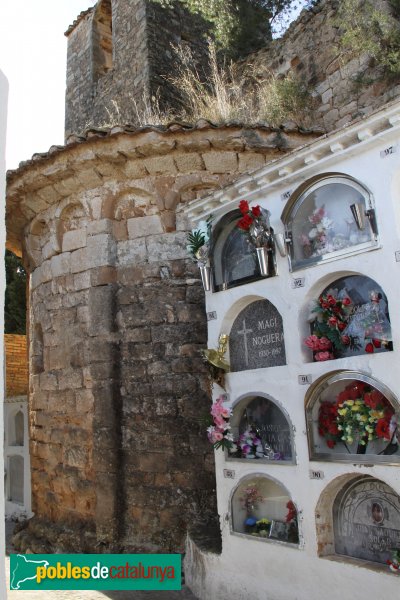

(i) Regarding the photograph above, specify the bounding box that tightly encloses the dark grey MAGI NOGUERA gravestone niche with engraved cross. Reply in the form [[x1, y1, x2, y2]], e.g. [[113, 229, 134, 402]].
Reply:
[[229, 300, 286, 371]]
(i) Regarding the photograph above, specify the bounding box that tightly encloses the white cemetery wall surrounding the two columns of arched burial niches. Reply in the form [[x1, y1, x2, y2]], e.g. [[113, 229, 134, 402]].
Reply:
[[186, 106, 400, 600]]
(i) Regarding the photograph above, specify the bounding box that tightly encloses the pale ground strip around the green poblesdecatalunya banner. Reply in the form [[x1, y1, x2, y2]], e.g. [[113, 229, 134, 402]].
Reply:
[[6, 521, 196, 600]]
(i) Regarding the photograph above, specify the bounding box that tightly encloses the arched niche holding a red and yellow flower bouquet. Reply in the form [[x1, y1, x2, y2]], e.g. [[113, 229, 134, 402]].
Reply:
[[306, 371, 400, 464]]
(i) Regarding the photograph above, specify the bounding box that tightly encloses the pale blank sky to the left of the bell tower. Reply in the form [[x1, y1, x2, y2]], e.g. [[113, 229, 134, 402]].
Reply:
[[0, 0, 95, 169]]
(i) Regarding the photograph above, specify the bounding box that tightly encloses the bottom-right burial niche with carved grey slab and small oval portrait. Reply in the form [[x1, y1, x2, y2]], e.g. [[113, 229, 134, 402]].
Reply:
[[333, 476, 400, 564]]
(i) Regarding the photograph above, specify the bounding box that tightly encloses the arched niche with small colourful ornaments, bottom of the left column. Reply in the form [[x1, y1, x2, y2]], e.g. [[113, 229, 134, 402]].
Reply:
[[230, 474, 299, 544]]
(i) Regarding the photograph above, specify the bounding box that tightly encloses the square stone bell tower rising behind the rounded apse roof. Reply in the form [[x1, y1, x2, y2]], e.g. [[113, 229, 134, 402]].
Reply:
[[65, 0, 207, 138]]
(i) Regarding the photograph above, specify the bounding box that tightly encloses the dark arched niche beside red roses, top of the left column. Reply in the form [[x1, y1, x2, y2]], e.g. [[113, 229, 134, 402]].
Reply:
[[211, 210, 268, 292]]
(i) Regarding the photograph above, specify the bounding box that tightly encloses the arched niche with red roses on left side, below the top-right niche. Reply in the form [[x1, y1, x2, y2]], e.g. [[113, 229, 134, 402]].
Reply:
[[304, 274, 393, 362]]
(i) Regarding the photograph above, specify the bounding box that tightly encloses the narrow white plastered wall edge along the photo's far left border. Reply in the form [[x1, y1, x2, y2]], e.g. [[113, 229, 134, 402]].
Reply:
[[0, 70, 8, 598]]
